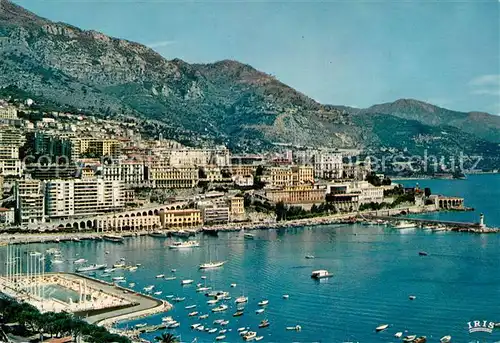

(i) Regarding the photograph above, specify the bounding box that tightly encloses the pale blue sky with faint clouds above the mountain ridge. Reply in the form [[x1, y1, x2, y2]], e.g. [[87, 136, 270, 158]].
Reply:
[[14, 0, 500, 115]]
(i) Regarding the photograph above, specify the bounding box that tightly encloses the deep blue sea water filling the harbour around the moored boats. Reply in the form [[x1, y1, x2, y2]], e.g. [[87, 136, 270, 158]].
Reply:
[[0, 175, 500, 343]]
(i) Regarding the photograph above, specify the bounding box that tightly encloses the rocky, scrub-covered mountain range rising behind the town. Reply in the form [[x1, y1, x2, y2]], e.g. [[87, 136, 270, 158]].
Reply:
[[0, 0, 500, 168]]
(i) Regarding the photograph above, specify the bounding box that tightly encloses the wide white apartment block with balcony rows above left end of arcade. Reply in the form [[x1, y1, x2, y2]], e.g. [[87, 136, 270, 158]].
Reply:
[[45, 179, 125, 218]]
